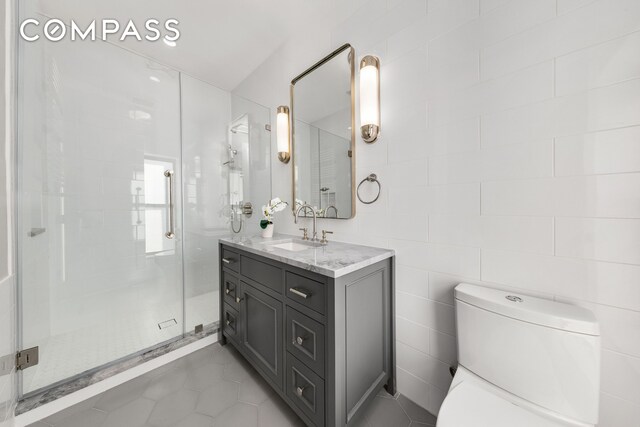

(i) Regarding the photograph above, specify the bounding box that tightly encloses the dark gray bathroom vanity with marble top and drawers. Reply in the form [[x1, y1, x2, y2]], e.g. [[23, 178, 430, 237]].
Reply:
[[219, 236, 395, 427]]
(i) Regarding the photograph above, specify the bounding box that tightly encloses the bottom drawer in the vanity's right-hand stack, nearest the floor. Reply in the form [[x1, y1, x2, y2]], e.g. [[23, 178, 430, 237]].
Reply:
[[285, 354, 324, 426]]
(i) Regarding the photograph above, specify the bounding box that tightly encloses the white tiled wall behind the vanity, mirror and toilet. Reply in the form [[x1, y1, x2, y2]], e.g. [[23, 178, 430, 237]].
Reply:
[[235, 0, 640, 427]]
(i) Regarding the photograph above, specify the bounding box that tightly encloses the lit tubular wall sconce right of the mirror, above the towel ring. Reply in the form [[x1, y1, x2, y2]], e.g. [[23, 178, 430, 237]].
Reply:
[[360, 55, 380, 143]]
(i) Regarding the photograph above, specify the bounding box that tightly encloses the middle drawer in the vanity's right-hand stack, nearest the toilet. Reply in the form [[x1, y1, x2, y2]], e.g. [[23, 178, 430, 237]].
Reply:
[[286, 307, 325, 377]]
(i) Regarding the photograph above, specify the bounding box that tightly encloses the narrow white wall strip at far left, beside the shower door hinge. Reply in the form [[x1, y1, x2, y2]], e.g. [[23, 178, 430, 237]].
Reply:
[[0, 1, 17, 427]]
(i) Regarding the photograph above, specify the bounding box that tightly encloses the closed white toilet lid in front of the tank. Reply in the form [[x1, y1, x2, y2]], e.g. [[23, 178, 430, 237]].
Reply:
[[437, 381, 567, 427]]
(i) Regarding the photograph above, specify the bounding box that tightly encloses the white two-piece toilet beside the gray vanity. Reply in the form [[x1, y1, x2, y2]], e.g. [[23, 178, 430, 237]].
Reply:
[[437, 283, 600, 427]]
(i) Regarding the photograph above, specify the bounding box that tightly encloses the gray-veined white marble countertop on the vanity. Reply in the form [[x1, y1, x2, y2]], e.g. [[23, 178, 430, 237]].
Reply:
[[220, 234, 395, 277]]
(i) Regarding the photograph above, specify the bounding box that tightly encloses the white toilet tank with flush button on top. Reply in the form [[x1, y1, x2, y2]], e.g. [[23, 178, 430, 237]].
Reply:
[[455, 283, 600, 424]]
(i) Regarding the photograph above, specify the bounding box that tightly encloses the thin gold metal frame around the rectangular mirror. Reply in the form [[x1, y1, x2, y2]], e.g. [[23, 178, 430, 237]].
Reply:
[[289, 43, 356, 220]]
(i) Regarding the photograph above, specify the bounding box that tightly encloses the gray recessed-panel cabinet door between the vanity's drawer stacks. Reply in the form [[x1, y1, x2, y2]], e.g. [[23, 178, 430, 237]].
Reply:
[[240, 282, 283, 388]]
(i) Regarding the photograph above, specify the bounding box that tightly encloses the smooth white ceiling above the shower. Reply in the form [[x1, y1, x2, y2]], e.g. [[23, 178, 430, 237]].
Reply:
[[27, 0, 332, 90]]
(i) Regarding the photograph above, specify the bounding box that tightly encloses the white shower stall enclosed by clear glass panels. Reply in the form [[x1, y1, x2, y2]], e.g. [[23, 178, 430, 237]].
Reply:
[[16, 3, 271, 396]]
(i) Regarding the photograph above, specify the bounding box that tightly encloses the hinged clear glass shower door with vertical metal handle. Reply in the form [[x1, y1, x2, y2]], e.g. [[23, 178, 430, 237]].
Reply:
[[18, 30, 184, 394]]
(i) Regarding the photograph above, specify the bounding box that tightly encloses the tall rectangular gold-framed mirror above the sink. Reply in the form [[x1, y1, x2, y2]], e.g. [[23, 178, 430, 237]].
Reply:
[[291, 44, 356, 219]]
